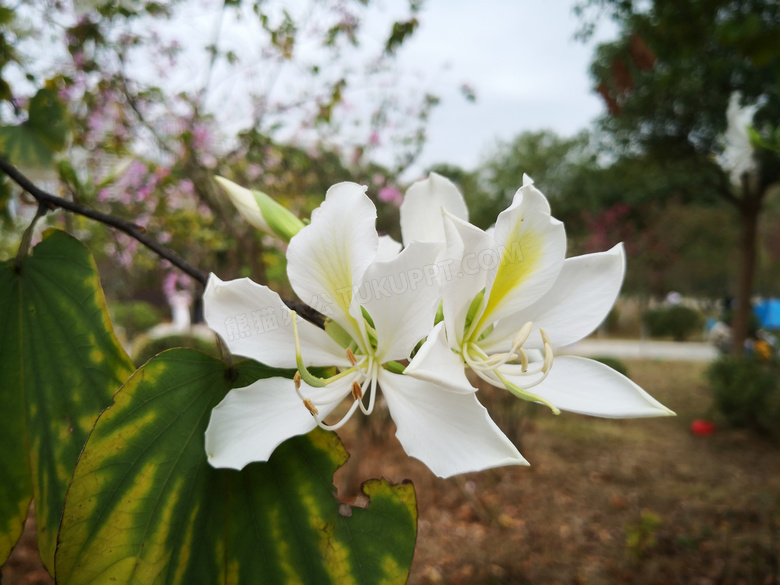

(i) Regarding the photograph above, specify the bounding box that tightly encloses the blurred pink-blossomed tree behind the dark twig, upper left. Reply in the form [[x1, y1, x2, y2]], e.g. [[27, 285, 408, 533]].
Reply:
[[0, 0, 437, 314]]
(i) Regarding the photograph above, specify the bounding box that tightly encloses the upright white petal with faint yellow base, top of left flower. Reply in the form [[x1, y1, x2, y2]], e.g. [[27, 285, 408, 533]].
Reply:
[[287, 183, 379, 339]]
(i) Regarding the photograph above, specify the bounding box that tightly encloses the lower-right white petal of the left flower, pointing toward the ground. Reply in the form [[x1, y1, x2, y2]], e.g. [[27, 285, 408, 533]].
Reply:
[[379, 370, 528, 477]]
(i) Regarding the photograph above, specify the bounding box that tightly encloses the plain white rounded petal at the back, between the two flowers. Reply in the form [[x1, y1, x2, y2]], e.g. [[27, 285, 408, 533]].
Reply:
[[401, 173, 469, 246]]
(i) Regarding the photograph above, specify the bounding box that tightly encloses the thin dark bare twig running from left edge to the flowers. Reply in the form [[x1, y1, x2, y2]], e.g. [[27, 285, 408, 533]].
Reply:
[[0, 156, 208, 287]]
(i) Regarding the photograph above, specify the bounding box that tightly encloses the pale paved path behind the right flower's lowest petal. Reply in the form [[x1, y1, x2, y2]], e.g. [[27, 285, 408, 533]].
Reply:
[[559, 339, 718, 362]]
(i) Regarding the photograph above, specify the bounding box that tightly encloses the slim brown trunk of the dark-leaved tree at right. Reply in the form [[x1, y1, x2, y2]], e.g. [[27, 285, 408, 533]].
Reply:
[[731, 181, 762, 355]]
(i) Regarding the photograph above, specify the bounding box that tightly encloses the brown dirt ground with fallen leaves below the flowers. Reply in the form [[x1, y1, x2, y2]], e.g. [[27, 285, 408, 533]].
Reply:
[[2, 362, 780, 585]]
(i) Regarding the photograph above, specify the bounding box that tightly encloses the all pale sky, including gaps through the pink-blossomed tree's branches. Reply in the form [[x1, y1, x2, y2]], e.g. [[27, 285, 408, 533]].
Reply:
[[143, 0, 616, 180]]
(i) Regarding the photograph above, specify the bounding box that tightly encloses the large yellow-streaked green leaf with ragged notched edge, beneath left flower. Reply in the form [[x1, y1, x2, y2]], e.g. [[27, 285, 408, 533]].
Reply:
[[56, 349, 417, 585]]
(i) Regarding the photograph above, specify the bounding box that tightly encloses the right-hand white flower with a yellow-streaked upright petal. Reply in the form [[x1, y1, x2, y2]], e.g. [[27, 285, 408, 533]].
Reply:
[[406, 177, 674, 418]]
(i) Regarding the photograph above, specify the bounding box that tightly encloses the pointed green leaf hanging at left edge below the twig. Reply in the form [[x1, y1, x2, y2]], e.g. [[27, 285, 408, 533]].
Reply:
[[0, 230, 133, 571]]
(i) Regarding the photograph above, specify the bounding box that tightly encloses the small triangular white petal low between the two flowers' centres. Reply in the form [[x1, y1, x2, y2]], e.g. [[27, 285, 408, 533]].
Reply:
[[404, 322, 476, 394]]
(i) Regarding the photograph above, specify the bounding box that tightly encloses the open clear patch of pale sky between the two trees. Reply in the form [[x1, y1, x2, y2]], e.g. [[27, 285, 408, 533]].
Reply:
[[394, 0, 616, 177]]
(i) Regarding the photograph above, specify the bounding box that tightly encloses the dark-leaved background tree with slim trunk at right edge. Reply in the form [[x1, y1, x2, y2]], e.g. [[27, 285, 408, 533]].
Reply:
[[580, 0, 780, 352]]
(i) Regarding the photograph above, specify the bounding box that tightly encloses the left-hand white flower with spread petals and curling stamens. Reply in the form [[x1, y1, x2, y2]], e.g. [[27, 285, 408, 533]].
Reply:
[[204, 183, 527, 477]]
